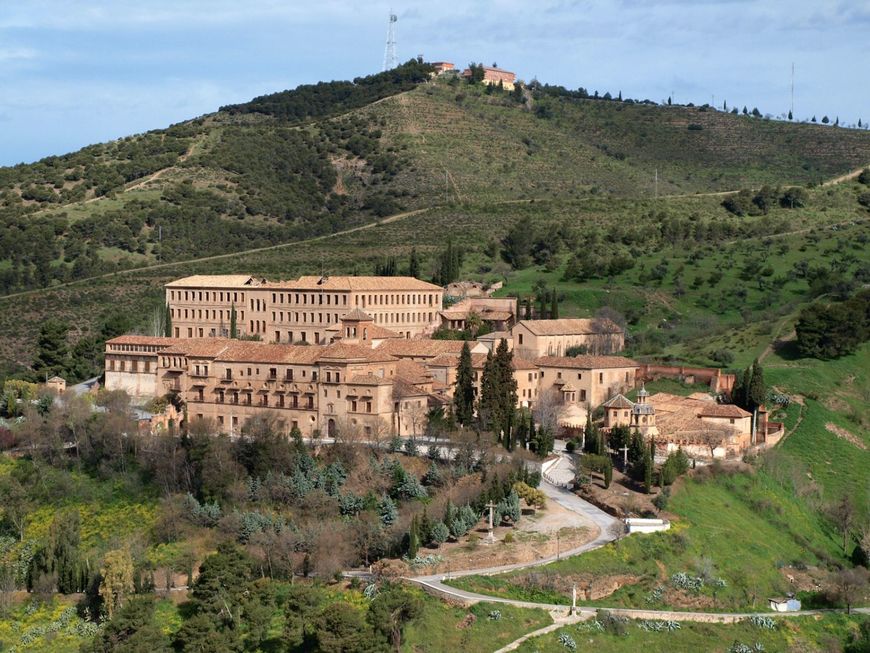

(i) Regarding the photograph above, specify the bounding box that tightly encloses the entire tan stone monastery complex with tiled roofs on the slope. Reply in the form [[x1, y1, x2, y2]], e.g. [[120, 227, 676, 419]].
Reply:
[[105, 275, 776, 457]]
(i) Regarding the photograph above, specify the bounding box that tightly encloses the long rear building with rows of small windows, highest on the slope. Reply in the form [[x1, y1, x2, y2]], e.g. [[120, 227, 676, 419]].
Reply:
[[166, 274, 444, 344]]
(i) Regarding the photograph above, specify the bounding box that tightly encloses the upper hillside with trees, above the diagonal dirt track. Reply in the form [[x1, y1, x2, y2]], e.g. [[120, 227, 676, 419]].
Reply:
[[0, 61, 870, 293]]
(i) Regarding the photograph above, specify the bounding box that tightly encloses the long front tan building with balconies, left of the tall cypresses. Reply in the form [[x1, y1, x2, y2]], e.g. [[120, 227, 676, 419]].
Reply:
[[106, 336, 432, 436]]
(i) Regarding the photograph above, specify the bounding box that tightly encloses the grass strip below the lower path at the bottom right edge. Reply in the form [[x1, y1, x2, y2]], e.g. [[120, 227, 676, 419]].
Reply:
[[517, 615, 866, 653]]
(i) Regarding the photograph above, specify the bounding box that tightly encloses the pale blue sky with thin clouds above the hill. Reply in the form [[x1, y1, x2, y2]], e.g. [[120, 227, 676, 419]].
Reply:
[[0, 0, 870, 165]]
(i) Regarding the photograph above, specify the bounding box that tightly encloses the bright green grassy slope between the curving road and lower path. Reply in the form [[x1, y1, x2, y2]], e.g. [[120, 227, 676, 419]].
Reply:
[[451, 471, 843, 611]]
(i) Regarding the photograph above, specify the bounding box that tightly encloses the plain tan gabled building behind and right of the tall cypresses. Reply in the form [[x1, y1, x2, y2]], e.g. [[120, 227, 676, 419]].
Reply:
[[511, 318, 625, 359]]
